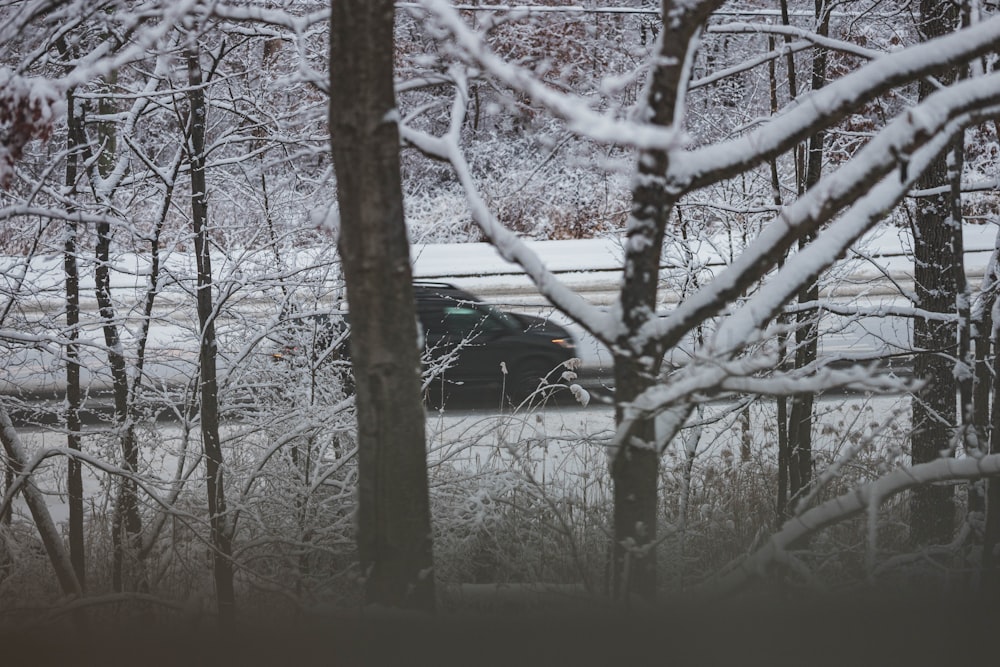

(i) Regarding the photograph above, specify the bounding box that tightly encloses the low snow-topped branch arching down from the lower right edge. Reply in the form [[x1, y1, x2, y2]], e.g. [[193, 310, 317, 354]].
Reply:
[[702, 454, 1000, 596]]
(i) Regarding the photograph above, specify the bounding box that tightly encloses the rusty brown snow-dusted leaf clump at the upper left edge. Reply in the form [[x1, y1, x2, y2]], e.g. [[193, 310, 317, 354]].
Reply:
[[0, 67, 62, 188]]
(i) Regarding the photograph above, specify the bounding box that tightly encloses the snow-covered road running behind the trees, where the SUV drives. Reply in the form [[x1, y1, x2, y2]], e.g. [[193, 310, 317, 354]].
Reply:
[[0, 225, 996, 396]]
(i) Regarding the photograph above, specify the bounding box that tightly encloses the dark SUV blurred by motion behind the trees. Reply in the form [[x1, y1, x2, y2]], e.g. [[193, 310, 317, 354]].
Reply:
[[273, 281, 576, 403]]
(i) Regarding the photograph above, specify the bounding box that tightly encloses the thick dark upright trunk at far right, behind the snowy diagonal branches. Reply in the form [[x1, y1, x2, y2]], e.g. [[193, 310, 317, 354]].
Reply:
[[900, 0, 962, 545]]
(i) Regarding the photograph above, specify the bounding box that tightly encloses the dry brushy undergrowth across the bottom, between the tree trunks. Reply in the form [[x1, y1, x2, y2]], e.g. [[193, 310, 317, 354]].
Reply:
[[0, 392, 977, 626]]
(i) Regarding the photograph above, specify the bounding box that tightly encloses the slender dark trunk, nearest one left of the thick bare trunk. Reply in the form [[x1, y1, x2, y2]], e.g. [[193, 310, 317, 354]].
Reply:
[[187, 45, 236, 630]]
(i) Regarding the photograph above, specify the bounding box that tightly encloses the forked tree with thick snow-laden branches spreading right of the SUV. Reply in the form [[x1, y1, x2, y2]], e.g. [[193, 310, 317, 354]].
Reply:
[[403, 0, 1000, 600]]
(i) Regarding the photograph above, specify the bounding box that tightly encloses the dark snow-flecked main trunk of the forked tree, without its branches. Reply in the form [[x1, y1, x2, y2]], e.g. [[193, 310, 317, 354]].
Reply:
[[611, 0, 721, 602]]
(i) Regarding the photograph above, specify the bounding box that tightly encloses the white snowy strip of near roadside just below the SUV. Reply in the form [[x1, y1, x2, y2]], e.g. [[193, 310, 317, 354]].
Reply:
[[15, 395, 909, 523]]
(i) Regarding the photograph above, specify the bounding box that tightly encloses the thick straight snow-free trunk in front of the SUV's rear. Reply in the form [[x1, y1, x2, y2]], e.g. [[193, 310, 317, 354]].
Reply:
[[330, 0, 435, 611]]
